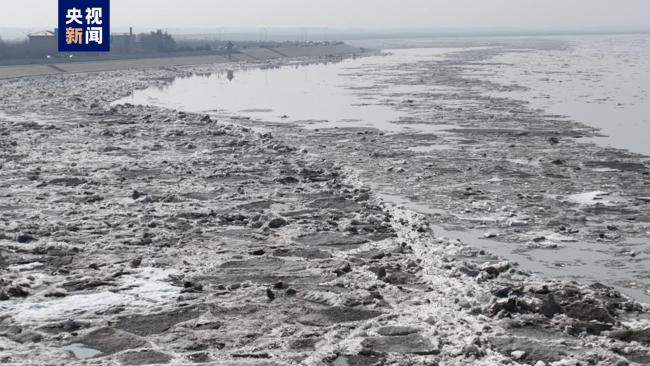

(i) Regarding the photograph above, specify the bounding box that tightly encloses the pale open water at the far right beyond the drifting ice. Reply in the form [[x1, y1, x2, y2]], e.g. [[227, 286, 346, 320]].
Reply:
[[480, 34, 650, 156]]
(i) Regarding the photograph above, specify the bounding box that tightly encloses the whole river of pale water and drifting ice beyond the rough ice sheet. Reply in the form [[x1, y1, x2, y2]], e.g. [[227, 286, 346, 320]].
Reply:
[[117, 42, 650, 302]]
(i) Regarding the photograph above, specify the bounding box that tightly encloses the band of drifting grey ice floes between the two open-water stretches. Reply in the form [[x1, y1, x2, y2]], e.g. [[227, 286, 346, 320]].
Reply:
[[227, 46, 650, 303]]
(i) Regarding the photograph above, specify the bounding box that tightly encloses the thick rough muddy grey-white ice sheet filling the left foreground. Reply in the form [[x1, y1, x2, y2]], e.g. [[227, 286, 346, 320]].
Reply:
[[0, 50, 650, 366]]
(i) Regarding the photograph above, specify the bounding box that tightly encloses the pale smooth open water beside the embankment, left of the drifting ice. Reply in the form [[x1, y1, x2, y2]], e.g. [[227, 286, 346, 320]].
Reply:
[[116, 48, 457, 132]]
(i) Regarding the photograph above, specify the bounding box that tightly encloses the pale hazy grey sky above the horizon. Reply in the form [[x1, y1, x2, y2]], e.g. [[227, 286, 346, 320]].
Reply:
[[0, 0, 650, 29]]
